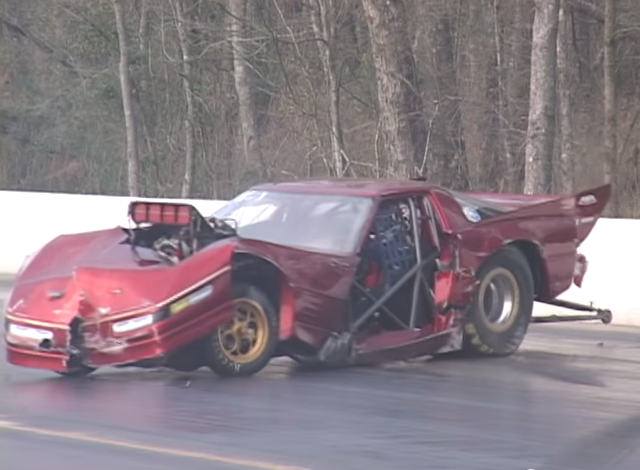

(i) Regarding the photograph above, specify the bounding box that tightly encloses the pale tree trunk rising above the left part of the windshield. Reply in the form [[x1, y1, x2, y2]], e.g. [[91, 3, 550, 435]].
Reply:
[[229, 0, 268, 179]]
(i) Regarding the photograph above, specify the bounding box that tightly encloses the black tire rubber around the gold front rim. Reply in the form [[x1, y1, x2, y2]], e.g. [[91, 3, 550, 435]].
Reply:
[[205, 283, 279, 377]]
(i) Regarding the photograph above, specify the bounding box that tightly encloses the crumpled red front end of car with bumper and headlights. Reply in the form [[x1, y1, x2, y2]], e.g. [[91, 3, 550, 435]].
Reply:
[[5, 260, 233, 372]]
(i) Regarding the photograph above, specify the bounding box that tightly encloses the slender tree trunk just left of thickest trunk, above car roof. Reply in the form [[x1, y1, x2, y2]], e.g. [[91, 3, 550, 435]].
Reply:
[[310, 0, 348, 177]]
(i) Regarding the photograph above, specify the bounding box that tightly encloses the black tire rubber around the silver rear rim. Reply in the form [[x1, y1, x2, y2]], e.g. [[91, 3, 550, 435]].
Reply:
[[464, 247, 535, 356]]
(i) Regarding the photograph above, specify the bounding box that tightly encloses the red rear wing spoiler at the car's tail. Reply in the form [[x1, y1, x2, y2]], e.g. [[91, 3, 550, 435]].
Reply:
[[476, 184, 611, 244]]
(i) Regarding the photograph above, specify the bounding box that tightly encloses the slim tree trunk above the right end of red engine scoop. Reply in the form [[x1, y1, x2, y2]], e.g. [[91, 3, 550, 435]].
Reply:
[[174, 0, 195, 197]]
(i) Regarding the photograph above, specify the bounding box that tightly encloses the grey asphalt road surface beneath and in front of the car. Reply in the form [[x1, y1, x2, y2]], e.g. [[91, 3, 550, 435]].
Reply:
[[0, 285, 640, 470]]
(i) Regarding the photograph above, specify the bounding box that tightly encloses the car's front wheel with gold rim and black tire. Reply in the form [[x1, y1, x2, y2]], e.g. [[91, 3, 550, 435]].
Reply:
[[205, 284, 279, 377]]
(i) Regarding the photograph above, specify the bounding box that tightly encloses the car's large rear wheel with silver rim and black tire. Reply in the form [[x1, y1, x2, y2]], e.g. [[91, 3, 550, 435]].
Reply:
[[463, 247, 535, 356]]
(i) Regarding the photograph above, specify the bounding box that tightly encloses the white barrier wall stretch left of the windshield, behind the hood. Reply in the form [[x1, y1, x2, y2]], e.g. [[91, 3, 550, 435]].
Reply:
[[0, 191, 226, 275]]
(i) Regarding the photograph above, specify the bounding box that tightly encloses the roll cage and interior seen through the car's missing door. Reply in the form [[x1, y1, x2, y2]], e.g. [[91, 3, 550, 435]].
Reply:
[[349, 194, 440, 334]]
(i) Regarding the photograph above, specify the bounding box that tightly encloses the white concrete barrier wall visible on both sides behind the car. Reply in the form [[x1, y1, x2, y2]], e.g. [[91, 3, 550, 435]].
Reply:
[[0, 191, 640, 326]]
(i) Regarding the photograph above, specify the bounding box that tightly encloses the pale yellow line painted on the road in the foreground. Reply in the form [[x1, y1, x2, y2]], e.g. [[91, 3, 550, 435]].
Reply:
[[0, 419, 311, 470]]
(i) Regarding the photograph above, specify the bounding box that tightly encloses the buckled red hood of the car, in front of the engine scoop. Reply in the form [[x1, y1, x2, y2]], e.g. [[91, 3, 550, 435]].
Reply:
[[7, 227, 234, 324]]
